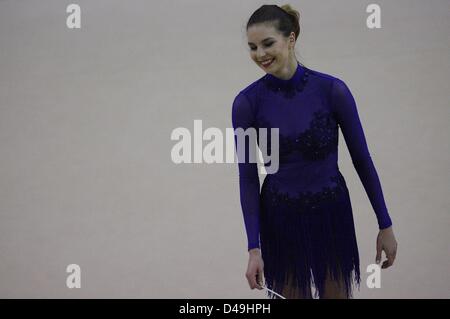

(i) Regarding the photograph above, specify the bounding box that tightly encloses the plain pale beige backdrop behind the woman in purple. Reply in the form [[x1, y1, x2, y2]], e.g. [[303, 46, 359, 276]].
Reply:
[[0, 0, 450, 298]]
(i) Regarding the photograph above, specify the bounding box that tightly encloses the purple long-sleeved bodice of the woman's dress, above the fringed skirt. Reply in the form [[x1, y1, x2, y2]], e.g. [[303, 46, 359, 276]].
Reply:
[[232, 64, 392, 250]]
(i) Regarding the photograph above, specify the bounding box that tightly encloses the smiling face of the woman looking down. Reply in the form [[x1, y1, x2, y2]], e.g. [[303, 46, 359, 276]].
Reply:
[[247, 24, 296, 74]]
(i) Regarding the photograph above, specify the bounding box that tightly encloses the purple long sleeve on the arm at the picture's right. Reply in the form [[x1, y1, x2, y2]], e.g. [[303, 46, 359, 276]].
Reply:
[[331, 78, 392, 229]]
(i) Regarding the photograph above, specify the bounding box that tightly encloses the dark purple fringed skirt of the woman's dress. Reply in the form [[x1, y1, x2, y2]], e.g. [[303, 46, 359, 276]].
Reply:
[[260, 172, 360, 298]]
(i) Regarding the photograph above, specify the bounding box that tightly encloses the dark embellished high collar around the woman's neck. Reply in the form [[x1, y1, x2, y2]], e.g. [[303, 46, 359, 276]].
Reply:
[[264, 61, 309, 96]]
